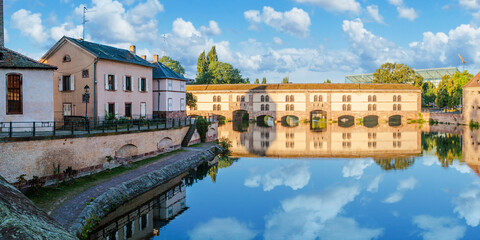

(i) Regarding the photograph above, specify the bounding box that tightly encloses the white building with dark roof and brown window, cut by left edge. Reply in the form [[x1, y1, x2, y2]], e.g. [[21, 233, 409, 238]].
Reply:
[[0, 47, 56, 125]]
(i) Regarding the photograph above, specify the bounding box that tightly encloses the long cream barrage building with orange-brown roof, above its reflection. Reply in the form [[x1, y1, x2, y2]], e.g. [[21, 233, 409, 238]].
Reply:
[[187, 84, 421, 121]]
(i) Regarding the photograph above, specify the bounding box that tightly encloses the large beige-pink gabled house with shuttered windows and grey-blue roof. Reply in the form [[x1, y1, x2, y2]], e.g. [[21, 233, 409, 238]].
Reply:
[[41, 37, 154, 121]]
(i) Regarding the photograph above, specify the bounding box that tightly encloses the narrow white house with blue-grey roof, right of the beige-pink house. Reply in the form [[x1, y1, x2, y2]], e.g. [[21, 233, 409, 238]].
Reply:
[[152, 55, 187, 118]]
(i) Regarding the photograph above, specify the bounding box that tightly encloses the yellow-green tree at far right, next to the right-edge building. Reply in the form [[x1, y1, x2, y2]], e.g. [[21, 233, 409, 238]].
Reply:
[[435, 71, 473, 108]]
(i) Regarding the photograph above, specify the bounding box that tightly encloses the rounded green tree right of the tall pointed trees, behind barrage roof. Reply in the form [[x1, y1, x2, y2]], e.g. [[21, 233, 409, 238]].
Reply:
[[208, 61, 245, 84]]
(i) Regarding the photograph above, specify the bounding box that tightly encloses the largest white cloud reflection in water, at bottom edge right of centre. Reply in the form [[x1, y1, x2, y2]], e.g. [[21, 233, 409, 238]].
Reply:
[[264, 186, 382, 240]]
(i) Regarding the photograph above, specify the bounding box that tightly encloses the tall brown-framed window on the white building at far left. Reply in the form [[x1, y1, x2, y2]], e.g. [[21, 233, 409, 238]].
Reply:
[[7, 74, 23, 114]]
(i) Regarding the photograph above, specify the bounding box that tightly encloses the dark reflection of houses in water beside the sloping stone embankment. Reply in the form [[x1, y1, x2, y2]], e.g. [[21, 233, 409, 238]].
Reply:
[[91, 174, 188, 240]]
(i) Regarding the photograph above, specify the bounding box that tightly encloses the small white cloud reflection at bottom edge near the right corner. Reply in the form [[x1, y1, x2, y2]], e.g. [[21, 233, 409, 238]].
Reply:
[[413, 215, 467, 240]]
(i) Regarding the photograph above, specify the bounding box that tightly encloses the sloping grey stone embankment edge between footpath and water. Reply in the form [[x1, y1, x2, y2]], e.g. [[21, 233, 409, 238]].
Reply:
[[69, 144, 223, 234]]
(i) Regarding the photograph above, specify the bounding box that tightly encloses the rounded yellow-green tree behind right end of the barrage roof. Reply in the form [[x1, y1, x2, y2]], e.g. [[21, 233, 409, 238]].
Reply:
[[373, 63, 423, 89]]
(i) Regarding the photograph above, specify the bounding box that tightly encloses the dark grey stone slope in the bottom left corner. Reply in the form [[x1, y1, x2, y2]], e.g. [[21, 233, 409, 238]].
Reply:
[[0, 176, 77, 240]]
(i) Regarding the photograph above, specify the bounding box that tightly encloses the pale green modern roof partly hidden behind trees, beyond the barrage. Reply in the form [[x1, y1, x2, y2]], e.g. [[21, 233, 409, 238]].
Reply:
[[345, 67, 458, 86]]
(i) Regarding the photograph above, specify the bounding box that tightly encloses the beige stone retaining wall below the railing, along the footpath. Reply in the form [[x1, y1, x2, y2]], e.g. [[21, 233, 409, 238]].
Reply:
[[0, 123, 218, 185]]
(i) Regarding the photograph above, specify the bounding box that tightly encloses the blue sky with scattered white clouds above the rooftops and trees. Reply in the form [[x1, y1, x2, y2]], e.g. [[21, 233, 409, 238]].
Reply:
[[4, 0, 480, 83]]
